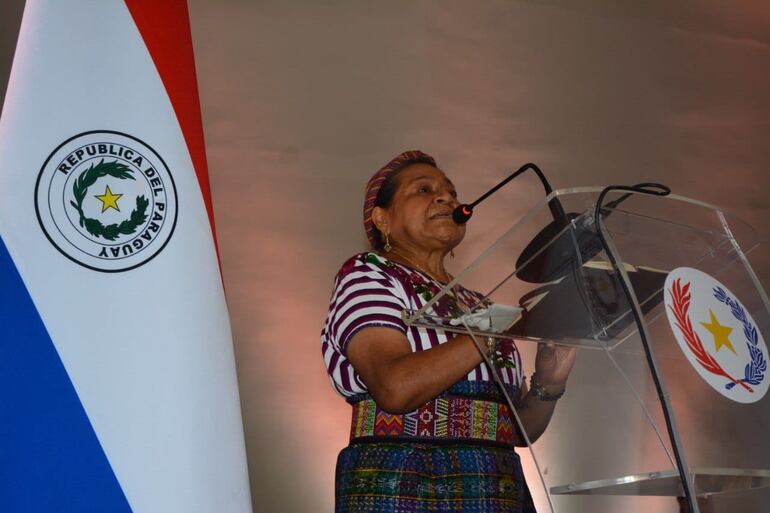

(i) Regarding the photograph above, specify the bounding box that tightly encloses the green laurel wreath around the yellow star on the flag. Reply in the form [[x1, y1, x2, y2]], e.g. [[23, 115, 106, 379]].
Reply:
[[70, 159, 150, 241]]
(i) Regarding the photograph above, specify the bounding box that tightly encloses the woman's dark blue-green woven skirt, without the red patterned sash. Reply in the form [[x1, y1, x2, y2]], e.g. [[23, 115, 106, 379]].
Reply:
[[335, 381, 535, 513]]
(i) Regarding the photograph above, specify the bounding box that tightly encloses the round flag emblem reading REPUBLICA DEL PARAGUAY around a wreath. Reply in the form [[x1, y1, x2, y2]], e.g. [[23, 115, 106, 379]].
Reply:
[[35, 130, 178, 272]]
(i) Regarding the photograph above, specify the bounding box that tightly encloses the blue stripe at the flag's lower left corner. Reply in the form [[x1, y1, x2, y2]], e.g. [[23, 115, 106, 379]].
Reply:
[[0, 238, 131, 513]]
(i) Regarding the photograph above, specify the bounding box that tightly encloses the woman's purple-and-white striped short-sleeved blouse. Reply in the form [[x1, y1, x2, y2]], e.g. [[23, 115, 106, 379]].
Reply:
[[321, 253, 523, 397]]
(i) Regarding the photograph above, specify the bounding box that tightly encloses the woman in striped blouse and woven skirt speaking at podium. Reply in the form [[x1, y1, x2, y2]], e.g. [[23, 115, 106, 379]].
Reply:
[[321, 151, 575, 513]]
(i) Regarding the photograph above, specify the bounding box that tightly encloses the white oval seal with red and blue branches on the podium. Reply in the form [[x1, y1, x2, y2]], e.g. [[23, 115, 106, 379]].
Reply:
[[665, 267, 769, 403]]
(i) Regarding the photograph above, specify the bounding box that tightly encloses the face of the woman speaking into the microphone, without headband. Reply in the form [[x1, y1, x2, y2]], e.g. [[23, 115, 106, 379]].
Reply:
[[374, 163, 465, 251]]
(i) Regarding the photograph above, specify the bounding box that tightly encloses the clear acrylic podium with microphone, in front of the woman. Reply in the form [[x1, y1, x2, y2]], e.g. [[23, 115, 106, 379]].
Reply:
[[403, 187, 770, 513]]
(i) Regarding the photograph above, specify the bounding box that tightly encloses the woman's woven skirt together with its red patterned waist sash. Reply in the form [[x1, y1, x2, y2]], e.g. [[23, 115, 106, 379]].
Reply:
[[335, 381, 535, 513]]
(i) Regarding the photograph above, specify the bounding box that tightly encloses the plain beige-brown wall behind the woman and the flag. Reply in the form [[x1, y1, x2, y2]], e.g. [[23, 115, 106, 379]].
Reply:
[[0, 0, 770, 512]]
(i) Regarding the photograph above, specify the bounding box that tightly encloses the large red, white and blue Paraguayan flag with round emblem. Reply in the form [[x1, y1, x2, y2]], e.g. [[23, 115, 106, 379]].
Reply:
[[0, 0, 251, 513]]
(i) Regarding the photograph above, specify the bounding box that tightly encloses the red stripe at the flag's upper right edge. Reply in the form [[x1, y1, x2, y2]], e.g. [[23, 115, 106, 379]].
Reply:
[[125, 0, 219, 258]]
